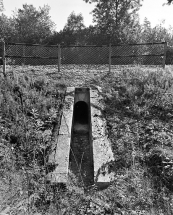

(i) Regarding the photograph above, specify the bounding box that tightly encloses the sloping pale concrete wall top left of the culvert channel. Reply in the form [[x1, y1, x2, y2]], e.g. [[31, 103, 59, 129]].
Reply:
[[47, 87, 75, 184]]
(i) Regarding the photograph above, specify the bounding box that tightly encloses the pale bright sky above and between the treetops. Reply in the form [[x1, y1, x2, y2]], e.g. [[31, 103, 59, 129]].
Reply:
[[3, 0, 173, 31]]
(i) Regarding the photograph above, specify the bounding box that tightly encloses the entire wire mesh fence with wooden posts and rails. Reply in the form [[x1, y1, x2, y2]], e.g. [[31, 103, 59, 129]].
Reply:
[[0, 42, 167, 75]]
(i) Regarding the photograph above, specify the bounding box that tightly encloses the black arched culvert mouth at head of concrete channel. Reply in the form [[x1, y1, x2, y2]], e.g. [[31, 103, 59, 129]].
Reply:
[[74, 101, 89, 124]]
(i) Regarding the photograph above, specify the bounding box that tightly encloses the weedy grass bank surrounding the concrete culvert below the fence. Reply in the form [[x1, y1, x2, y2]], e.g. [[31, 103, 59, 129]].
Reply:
[[0, 66, 173, 215]]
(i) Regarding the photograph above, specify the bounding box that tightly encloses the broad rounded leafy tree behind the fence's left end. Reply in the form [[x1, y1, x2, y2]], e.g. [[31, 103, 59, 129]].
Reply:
[[13, 4, 55, 43]]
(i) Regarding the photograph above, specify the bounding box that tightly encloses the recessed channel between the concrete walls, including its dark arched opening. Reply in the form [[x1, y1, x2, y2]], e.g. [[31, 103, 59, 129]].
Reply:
[[69, 89, 94, 187]]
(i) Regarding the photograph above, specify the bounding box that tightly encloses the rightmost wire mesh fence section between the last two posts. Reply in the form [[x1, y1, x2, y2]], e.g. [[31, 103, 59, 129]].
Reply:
[[111, 43, 166, 67]]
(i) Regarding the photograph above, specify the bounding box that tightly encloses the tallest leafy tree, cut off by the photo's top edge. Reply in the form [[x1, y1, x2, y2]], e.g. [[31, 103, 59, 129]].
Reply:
[[84, 0, 142, 42]]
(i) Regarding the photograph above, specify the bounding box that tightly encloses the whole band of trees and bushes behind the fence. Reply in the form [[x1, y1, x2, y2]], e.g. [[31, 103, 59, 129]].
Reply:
[[0, 0, 173, 46]]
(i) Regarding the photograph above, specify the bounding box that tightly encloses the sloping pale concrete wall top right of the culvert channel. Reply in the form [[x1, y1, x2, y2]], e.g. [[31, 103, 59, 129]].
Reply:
[[90, 90, 114, 188]]
